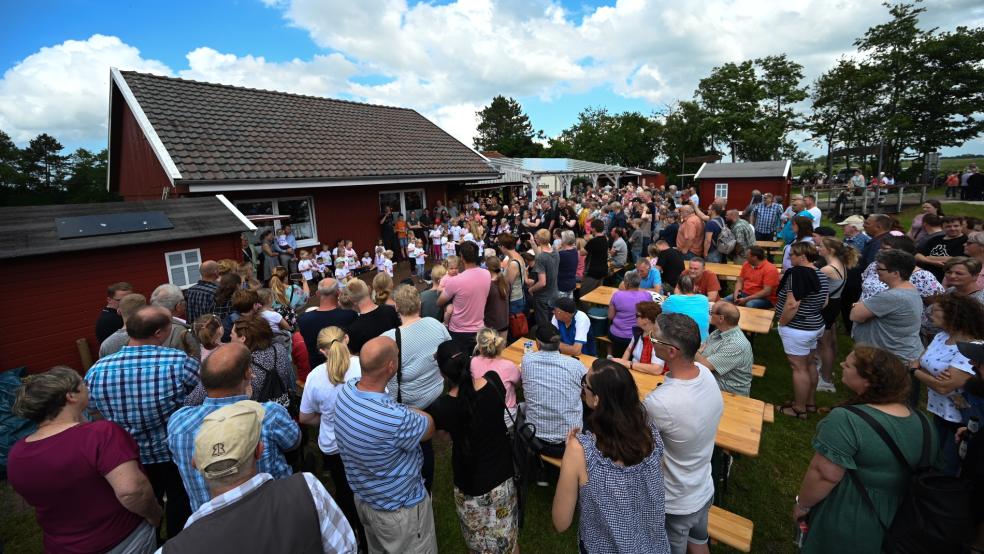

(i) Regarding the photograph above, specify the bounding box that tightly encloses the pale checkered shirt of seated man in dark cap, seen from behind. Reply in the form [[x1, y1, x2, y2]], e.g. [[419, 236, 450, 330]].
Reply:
[[522, 351, 587, 444]]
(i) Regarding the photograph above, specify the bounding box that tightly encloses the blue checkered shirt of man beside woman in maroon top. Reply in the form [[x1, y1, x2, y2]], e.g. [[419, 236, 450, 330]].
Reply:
[[85, 345, 199, 464]]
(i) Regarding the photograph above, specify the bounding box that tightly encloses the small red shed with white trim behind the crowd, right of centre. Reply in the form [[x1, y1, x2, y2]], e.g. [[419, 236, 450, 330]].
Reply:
[[694, 160, 792, 210]]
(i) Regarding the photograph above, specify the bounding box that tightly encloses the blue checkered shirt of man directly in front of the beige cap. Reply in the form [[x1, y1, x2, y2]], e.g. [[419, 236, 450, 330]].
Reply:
[[167, 395, 301, 511]]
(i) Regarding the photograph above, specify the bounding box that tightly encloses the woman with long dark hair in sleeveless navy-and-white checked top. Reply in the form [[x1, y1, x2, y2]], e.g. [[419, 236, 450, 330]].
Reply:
[[553, 360, 670, 554]]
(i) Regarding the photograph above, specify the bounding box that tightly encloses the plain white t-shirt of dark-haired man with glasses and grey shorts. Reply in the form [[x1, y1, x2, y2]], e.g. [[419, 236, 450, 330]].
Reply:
[[643, 362, 724, 515]]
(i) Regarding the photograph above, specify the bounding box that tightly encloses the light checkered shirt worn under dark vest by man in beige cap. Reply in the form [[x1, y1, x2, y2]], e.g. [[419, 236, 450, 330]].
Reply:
[[181, 473, 358, 553]]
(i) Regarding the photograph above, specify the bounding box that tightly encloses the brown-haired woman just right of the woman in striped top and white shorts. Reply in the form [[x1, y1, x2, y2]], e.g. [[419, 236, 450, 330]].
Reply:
[[817, 237, 859, 392]]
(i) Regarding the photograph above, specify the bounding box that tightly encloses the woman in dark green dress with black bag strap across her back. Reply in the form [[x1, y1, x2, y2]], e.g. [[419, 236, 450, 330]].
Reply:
[[793, 346, 939, 554]]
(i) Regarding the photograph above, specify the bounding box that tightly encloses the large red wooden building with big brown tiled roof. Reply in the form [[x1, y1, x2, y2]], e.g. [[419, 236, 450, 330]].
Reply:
[[109, 69, 499, 252]]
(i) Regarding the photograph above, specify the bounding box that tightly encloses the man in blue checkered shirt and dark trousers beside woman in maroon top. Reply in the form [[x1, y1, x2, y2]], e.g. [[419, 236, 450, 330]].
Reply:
[[85, 306, 198, 537]]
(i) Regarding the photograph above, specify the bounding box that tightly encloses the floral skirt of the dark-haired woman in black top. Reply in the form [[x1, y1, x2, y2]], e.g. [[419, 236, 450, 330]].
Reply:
[[454, 477, 519, 554]]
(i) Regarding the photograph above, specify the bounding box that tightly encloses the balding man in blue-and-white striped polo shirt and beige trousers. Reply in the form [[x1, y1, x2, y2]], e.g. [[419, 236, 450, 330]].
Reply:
[[335, 337, 437, 554]]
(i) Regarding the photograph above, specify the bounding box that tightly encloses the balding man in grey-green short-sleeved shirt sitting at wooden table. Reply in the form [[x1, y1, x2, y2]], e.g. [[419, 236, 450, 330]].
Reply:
[[695, 302, 753, 396]]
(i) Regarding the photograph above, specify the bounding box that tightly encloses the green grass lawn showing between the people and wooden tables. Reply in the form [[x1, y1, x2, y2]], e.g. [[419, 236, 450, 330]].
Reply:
[[0, 204, 984, 553]]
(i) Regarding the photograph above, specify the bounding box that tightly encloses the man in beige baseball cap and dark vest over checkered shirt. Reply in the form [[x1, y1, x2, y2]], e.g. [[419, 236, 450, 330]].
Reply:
[[158, 400, 357, 554]]
